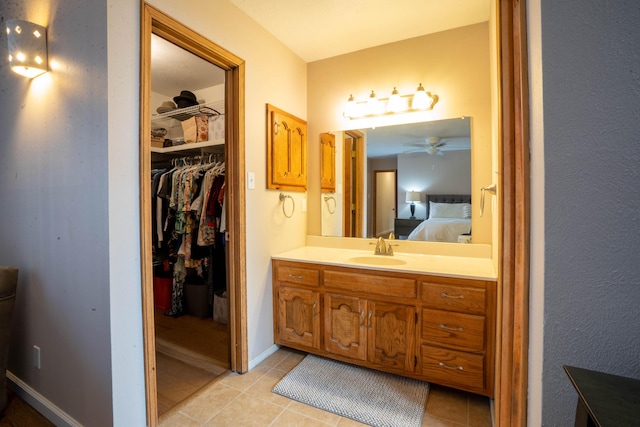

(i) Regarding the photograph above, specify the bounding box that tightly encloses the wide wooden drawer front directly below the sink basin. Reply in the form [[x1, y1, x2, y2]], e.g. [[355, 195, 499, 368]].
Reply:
[[324, 270, 417, 298]]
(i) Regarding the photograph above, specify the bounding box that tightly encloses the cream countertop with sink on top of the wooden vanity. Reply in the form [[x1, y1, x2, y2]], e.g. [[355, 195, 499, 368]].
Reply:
[[273, 246, 497, 280]]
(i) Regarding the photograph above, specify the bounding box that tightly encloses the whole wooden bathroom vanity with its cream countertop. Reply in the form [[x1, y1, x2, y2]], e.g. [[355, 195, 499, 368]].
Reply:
[[272, 248, 496, 397]]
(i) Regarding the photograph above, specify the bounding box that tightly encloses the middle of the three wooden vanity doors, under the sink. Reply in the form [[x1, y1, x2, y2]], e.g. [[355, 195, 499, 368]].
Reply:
[[324, 294, 367, 360]]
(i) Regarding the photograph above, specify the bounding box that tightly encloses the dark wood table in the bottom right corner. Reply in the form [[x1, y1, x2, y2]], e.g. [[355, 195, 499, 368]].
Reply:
[[564, 366, 640, 427]]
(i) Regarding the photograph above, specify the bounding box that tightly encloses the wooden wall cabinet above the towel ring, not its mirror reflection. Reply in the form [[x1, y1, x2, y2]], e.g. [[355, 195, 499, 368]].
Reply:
[[267, 104, 307, 191]]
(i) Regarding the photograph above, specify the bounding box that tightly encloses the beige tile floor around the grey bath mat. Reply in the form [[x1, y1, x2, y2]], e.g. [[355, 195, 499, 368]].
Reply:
[[160, 348, 492, 427]]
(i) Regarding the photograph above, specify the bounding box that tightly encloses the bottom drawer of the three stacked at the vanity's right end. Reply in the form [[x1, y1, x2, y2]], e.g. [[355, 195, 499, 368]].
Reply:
[[422, 345, 485, 390]]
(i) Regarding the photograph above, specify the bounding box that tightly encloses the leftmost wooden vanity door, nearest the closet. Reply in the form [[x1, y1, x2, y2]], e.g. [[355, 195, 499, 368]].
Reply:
[[278, 287, 320, 349]]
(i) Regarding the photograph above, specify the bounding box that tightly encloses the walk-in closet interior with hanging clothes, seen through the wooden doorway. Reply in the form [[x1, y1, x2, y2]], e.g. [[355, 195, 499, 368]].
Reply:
[[150, 35, 230, 414]]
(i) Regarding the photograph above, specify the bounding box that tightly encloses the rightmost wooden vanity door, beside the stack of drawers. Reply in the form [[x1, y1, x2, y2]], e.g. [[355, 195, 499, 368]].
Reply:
[[367, 301, 417, 372]]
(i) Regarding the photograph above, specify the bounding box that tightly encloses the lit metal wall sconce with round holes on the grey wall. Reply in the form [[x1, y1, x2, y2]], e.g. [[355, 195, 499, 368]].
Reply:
[[7, 20, 48, 79]]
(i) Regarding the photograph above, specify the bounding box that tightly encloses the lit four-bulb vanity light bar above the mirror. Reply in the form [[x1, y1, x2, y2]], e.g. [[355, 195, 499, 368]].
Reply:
[[344, 83, 438, 119]]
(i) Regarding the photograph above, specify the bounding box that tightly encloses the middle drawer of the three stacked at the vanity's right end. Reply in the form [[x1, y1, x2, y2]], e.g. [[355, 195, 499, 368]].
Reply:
[[422, 309, 485, 352]]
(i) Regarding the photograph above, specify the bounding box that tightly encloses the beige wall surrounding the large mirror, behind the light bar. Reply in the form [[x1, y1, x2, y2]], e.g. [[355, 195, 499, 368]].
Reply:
[[307, 23, 492, 243]]
